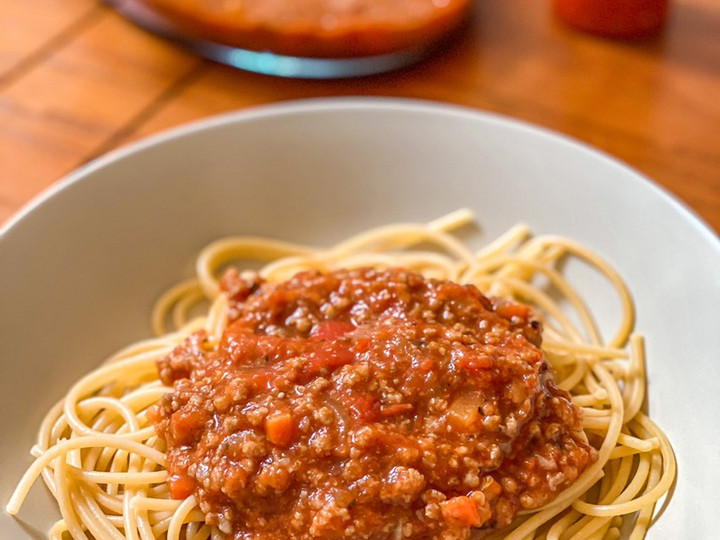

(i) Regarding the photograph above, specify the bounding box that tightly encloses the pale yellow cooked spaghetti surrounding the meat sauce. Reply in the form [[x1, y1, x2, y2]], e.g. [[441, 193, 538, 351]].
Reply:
[[7, 210, 676, 540]]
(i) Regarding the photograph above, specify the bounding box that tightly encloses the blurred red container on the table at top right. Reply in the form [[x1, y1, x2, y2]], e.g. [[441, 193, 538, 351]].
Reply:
[[553, 0, 668, 38]]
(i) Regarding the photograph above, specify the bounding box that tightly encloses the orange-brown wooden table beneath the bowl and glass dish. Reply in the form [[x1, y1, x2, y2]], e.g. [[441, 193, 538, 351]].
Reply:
[[0, 0, 720, 231]]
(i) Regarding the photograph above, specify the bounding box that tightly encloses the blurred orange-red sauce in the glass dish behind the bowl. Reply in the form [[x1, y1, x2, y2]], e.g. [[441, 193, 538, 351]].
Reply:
[[143, 0, 472, 58]]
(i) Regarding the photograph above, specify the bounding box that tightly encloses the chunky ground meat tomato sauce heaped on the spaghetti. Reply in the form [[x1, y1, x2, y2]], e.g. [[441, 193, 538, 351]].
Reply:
[[150, 269, 594, 540]]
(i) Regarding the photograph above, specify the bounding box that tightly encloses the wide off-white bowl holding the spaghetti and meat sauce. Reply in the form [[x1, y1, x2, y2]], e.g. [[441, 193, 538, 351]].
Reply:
[[0, 99, 720, 540]]
